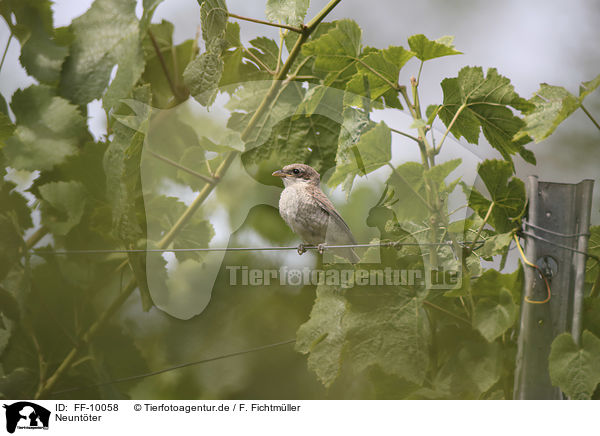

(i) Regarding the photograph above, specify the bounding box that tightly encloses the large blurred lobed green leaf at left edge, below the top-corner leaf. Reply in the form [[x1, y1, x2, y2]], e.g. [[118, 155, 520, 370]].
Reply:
[[4, 85, 89, 171]]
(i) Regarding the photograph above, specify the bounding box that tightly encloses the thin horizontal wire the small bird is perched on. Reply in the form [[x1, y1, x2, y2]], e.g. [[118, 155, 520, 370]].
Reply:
[[32, 240, 485, 255]]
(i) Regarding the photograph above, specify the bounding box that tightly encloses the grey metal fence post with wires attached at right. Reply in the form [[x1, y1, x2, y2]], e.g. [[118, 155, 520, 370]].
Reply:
[[514, 176, 594, 400]]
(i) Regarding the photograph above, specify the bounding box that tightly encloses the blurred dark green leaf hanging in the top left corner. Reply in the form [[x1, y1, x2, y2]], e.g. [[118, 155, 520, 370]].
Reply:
[[0, 0, 68, 84]]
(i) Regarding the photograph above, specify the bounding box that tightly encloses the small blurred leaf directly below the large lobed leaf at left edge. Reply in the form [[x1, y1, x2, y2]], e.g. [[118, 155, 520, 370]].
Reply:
[[39, 181, 87, 235]]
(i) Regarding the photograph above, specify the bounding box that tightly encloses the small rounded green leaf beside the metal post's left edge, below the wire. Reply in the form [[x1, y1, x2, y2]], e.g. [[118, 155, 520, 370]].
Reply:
[[473, 289, 518, 342]]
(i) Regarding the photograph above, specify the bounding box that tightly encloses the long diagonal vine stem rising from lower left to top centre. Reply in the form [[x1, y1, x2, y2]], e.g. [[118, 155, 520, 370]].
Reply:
[[34, 0, 341, 399]]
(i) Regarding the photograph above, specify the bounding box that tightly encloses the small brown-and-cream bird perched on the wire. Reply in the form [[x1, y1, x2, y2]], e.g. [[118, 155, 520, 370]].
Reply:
[[272, 163, 360, 263]]
